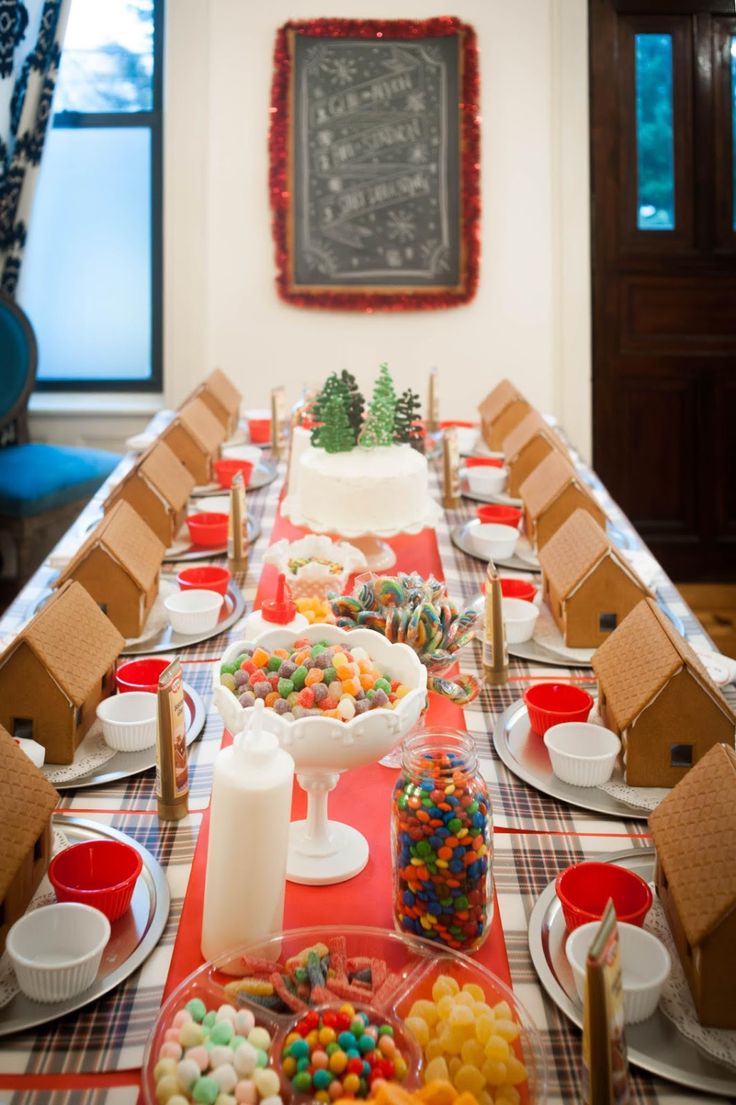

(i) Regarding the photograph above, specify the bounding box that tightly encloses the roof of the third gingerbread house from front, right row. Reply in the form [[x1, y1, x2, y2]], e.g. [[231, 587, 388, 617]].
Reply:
[[539, 509, 649, 601]]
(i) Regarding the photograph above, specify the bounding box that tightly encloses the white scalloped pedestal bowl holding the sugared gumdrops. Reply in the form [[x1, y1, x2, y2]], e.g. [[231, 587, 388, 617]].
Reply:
[[213, 624, 427, 885]]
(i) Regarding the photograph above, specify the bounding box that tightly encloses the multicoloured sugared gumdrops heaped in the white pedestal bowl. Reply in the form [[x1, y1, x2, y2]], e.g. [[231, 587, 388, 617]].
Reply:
[[220, 639, 409, 722]]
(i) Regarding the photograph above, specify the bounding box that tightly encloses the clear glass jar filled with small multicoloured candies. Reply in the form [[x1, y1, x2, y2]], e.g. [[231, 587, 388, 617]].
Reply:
[[391, 728, 493, 951]]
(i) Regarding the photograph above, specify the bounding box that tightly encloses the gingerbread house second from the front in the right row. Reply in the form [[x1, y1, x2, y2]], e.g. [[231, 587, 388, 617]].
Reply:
[[592, 599, 736, 787]]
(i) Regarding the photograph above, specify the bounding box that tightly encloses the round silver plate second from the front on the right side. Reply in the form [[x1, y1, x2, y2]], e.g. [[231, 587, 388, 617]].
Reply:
[[493, 698, 650, 821]]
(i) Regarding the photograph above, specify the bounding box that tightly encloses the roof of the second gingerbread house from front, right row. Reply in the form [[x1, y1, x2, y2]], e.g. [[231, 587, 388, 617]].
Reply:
[[592, 599, 736, 729]]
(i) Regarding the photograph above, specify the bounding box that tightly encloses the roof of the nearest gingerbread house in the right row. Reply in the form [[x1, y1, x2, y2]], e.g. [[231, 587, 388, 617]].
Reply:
[[649, 745, 736, 947]]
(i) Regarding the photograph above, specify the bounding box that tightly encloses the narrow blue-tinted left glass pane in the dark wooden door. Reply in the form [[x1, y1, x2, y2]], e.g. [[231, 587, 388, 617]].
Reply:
[[634, 34, 675, 230]]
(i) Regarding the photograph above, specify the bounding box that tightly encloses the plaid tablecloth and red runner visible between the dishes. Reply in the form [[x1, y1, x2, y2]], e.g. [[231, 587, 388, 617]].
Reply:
[[0, 424, 736, 1105]]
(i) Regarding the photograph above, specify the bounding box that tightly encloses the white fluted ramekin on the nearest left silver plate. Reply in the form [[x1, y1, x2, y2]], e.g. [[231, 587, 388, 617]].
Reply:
[[6, 902, 111, 1002]]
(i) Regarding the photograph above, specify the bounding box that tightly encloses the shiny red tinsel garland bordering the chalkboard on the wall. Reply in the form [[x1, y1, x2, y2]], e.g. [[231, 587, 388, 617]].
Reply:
[[269, 15, 481, 314]]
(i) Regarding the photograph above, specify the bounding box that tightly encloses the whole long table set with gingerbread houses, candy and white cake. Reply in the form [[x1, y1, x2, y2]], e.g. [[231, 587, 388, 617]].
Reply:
[[0, 366, 736, 1105]]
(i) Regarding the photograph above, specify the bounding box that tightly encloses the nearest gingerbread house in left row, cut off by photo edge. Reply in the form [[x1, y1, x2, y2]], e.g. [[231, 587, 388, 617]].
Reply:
[[0, 725, 59, 955]]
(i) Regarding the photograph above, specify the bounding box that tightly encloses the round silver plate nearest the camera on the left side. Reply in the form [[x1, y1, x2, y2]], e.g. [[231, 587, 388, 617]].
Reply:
[[0, 813, 170, 1036]]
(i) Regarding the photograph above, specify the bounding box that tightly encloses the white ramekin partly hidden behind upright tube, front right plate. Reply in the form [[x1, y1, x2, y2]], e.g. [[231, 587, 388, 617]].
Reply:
[[565, 920, 672, 1024]]
